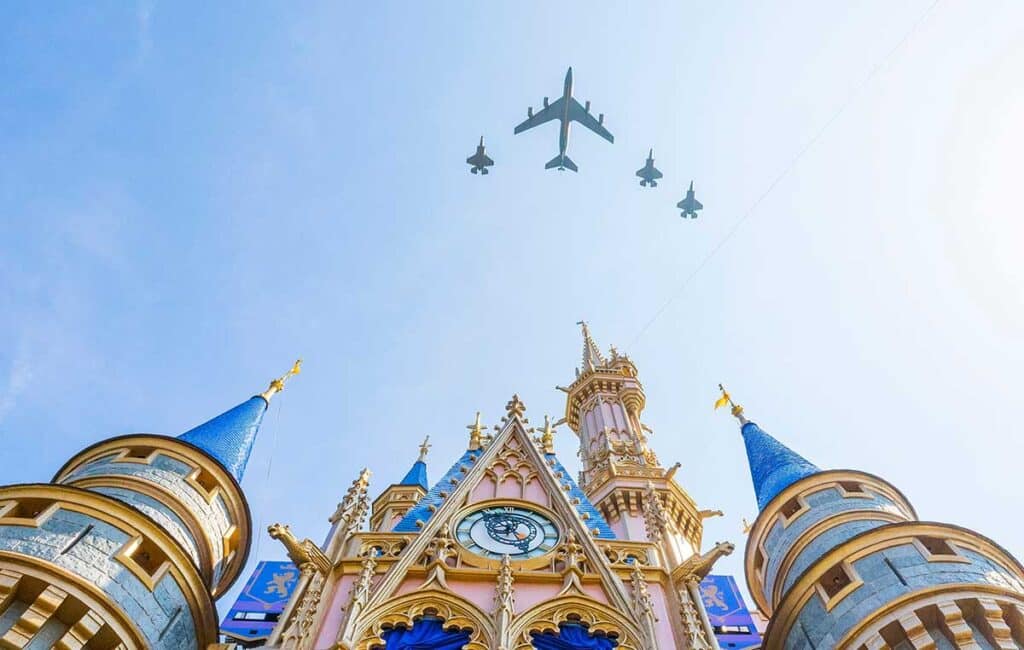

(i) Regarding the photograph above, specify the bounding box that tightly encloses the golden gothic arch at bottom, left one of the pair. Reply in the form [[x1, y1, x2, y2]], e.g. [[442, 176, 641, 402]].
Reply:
[[355, 589, 496, 650]]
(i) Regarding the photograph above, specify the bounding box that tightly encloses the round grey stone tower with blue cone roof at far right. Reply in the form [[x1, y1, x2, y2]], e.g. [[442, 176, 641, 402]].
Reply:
[[723, 395, 1024, 650]]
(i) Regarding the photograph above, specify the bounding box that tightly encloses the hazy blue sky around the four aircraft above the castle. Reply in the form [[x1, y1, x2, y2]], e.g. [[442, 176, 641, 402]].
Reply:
[[0, 0, 1024, 607]]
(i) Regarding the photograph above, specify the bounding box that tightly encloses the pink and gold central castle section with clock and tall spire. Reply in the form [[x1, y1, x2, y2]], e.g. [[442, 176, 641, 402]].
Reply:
[[268, 330, 732, 650]]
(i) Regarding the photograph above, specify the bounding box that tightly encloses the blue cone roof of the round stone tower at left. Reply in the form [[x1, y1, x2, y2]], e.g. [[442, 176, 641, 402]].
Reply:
[[178, 395, 267, 481]]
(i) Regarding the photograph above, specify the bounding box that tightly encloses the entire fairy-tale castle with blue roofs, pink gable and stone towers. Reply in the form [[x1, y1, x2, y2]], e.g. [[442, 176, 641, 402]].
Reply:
[[0, 326, 1024, 650]]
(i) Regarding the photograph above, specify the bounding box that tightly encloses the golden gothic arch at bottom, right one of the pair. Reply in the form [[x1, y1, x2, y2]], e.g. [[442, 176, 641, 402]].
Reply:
[[509, 595, 643, 650]]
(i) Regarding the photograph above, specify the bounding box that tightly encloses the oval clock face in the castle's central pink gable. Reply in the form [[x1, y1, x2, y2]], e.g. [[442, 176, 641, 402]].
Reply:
[[456, 506, 558, 560]]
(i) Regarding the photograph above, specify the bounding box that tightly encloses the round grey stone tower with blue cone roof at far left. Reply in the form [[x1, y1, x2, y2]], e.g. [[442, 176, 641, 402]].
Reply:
[[0, 364, 298, 650]]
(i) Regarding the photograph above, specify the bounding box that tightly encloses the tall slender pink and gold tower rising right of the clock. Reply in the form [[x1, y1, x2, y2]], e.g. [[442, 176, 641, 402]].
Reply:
[[559, 322, 721, 566]]
